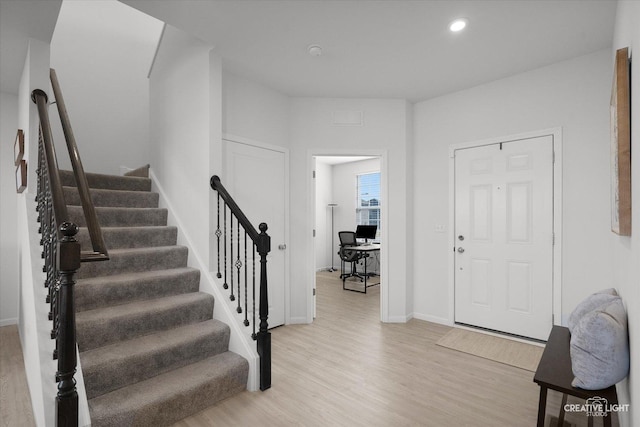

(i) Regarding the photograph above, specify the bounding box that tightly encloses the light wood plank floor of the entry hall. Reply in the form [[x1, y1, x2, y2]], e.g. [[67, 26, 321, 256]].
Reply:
[[0, 273, 617, 427]]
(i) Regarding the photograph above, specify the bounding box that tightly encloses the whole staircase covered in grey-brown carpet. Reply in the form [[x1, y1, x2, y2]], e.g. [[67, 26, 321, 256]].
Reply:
[[61, 168, 248, 427]]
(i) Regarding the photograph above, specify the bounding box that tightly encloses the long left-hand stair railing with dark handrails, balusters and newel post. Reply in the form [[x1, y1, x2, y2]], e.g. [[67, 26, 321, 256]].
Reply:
[[31, 70, 109, 427]]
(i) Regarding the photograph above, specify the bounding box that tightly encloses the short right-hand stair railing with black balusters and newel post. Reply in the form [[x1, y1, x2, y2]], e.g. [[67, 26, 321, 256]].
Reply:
[[210, 175, 271, 390]]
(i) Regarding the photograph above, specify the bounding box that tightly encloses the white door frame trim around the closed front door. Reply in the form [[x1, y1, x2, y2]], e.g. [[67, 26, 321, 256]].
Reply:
[[447, 127, 563, 332]]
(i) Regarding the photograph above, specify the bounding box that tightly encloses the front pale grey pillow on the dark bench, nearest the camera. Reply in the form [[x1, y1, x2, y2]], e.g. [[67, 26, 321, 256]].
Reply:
[[570, 297, 629, 390]]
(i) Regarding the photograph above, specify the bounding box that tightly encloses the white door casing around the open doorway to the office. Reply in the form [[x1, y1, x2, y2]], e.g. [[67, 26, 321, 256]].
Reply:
[[305, 148, 390, 323]]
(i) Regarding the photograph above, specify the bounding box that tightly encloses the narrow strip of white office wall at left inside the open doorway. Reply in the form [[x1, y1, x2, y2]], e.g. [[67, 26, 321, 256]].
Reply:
[[314, 157, 332, 270]]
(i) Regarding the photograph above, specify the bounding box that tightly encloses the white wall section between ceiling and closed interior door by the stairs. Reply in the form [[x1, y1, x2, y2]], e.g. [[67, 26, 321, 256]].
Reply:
[[222, 69, 290, 147]]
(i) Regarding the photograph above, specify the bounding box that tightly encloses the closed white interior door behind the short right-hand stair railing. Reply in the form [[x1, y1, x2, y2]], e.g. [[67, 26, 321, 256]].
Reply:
[[223, 140, 287, 327]]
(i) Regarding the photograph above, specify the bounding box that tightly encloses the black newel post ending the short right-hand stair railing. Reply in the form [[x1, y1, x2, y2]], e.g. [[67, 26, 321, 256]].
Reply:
[[257, 222, 271, 390]]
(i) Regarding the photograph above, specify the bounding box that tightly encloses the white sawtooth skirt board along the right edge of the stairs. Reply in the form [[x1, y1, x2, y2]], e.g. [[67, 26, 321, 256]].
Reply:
[[149, 169, 260, 391]]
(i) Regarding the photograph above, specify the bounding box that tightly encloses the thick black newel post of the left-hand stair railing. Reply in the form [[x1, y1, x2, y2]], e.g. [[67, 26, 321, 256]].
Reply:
[[56, 222, 80, 427]]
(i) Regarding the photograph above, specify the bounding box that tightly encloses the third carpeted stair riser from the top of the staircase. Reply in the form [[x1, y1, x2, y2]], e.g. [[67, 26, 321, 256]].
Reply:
[[67, 206, 167, 227]]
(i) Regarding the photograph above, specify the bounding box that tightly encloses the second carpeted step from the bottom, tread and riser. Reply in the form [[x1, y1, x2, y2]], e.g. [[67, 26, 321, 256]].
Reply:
[[80, 319, 230, 398]]
